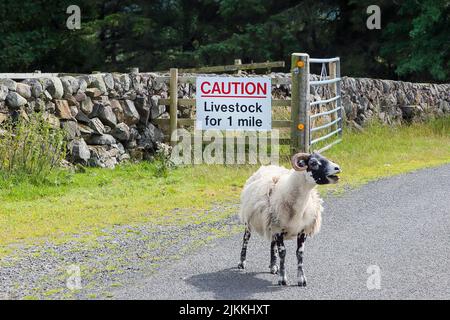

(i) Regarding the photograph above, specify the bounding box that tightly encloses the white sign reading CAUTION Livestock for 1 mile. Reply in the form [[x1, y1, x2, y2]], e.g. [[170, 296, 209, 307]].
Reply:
[[195, 77, 272, 131]]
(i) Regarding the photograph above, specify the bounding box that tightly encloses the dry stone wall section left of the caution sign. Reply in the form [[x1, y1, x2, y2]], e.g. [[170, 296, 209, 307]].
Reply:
[[0, 73, 170, 167]]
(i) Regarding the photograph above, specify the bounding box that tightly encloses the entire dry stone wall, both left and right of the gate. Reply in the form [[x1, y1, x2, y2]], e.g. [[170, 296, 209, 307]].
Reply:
[[0, 73, 450, 167]]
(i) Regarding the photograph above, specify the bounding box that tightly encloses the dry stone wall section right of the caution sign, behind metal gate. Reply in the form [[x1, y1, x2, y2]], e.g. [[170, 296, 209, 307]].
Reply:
[[272, 73, 450, 126]]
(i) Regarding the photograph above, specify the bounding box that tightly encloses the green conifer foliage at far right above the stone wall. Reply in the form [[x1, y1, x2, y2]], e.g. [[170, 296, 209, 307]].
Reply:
[[381, 0, 450, 81]]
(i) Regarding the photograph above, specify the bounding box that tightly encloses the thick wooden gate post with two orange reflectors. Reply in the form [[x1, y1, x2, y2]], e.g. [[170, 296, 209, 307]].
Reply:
[[291, 53, 310, 154]]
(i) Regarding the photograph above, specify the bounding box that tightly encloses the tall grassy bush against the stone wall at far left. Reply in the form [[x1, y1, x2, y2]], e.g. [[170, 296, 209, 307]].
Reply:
[[0, 113, 66, 184]]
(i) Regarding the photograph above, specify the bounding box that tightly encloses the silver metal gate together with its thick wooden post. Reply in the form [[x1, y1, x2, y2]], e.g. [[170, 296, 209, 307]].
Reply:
[[291, 53, 343, 152]]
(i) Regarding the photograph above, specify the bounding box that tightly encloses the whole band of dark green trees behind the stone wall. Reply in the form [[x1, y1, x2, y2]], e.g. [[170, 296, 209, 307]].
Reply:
[[0, 0, 450, 82]]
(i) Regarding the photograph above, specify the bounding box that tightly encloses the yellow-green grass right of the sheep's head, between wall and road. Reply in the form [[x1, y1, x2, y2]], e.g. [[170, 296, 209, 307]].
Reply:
[[316, 117, 450, 190]]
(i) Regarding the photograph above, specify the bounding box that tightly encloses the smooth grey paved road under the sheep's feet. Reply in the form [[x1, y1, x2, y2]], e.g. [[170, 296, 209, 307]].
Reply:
[[114, 165, 450, 299]]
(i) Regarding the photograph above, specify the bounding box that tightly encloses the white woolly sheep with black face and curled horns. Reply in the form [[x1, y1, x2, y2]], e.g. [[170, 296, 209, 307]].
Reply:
[[238, 153, 341, 287]]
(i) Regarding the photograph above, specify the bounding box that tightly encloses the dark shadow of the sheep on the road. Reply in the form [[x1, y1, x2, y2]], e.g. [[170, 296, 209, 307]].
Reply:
[[186, 268, 280, 300]]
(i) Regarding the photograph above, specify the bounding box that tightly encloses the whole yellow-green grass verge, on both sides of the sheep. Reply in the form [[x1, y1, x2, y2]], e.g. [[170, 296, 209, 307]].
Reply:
[[0, 118, 450, 251]]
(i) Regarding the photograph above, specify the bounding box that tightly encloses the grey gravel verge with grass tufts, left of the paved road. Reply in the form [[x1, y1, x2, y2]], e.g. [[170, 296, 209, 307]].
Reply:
[[0, 204, 240, 299]]
